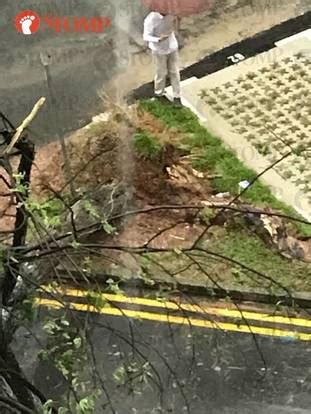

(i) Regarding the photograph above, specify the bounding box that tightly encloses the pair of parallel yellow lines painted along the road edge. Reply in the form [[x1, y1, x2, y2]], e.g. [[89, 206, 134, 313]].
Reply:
[[36, 289, 311, 341]]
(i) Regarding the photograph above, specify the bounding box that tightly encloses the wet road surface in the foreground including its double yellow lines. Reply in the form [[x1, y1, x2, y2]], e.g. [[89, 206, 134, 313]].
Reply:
[[26, 290, 311, 414]]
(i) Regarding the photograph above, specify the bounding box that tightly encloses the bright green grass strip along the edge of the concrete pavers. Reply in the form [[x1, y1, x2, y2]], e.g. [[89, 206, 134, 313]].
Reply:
[[139, 100, 311, 237]]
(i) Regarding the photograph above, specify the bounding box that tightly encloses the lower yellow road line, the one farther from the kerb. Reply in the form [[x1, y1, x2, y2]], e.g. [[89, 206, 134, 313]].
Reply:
[[36, 299, 311, 341]]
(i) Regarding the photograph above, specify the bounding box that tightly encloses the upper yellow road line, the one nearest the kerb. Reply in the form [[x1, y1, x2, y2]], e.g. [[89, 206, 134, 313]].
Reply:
[[44, 289, 311, 328]]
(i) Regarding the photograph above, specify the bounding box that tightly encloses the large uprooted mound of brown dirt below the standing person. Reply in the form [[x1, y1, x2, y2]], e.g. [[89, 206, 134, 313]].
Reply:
[[62, 110, 214, 207]]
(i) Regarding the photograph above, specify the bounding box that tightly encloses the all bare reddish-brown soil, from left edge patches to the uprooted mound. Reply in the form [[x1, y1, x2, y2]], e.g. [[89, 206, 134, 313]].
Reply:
[[0, 108, 214, 247]]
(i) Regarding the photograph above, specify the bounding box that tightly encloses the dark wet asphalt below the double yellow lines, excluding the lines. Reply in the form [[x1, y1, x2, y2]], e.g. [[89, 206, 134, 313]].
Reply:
[[29, 315, 311, 414]]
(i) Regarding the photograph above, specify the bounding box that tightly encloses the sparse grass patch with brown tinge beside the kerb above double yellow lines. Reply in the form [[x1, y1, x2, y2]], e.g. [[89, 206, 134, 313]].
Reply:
[[144, 227, 311, 294]]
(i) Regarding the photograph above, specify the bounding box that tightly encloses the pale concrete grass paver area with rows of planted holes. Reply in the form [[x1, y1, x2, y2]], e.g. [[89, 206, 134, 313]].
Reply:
[[182, 37, 311, 220]]
